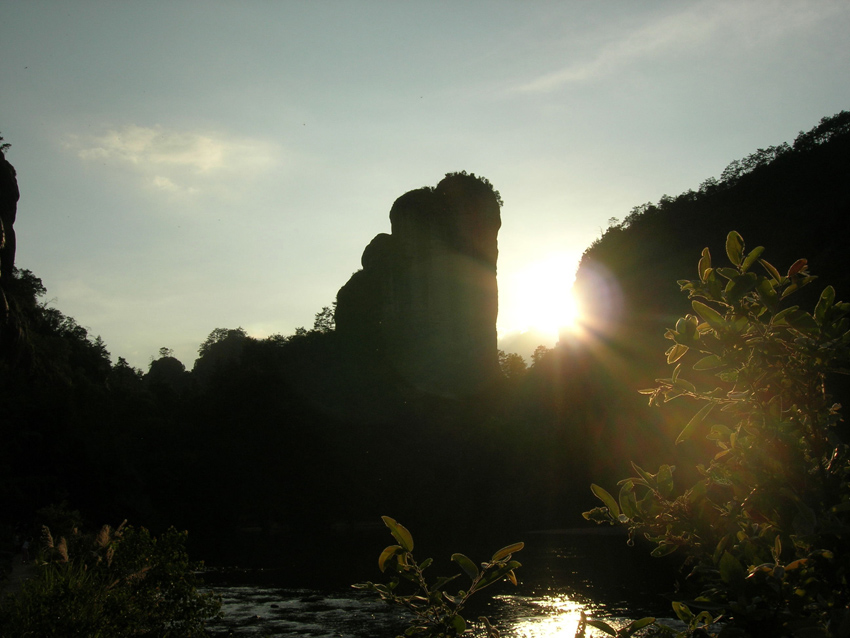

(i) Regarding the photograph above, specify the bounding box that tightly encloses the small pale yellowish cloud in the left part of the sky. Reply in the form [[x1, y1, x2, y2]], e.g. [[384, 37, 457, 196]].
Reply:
[[65, 124, 280, 194]]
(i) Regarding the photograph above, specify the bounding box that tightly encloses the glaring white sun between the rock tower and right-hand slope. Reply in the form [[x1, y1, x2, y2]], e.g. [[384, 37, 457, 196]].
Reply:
[[499, 253, 580, 339]]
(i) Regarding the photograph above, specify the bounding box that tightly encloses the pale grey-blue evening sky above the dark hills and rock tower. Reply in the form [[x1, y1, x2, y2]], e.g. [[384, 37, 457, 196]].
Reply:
[[0, 0, 850, 369]]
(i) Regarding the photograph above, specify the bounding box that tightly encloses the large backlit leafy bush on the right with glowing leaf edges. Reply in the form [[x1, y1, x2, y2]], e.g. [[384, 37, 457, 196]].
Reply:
[[584, 231, 850, 637]]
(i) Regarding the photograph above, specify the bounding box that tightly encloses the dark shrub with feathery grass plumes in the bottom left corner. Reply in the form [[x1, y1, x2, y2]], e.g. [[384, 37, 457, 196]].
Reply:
[[0, 524, 221, 638]]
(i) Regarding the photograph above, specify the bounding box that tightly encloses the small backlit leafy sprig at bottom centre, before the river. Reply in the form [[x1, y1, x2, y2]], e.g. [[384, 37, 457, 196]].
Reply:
[[354, 516, 524, 638]]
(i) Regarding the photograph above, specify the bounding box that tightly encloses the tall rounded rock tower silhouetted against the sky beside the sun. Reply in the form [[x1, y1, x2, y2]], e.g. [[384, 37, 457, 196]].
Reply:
[[335, 175, 501, 396]]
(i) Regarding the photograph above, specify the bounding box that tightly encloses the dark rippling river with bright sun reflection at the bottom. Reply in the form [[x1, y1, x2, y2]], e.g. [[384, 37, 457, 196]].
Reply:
[[199, 530, 676, 638]]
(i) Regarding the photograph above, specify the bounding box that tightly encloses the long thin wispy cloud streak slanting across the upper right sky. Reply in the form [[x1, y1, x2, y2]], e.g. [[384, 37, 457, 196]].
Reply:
[[515, 1, 838, 93]]
